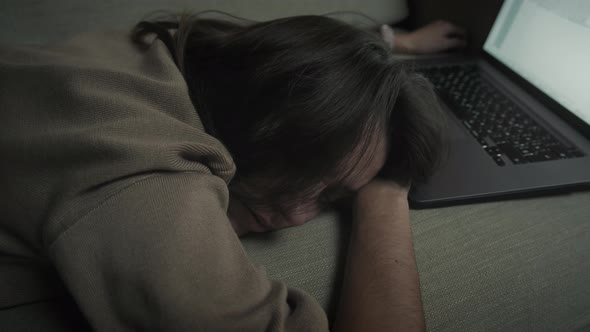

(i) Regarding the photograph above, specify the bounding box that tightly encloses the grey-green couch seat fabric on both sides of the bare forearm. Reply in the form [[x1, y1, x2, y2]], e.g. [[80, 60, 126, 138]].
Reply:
[[242, 192, 590, 331]]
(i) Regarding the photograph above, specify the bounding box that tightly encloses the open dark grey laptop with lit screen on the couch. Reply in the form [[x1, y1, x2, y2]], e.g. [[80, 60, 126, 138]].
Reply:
[[409, 0, 590, 208]]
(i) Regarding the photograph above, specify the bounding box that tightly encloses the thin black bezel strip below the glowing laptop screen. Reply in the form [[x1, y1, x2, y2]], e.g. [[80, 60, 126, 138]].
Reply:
[[481, 40, 590, 139]]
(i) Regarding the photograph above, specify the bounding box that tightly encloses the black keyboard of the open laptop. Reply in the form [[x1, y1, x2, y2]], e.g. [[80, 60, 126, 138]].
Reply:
[[419, 65, 584, 166]]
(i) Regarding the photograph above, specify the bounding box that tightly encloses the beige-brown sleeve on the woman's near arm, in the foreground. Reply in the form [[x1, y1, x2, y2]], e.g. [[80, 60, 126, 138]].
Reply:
[[49, 172, 328, 331]]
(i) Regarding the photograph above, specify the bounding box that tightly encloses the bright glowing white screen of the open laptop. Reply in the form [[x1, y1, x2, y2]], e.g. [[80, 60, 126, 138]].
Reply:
[[484, 0, 590, 124]]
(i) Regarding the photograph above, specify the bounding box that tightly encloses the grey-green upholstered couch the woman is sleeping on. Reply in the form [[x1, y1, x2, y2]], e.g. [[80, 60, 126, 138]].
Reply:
[[0, 0, 590, 332]]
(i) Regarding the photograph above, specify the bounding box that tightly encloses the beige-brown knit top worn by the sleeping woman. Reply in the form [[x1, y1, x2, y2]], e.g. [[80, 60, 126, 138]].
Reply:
[[0, 31, 328, 331]]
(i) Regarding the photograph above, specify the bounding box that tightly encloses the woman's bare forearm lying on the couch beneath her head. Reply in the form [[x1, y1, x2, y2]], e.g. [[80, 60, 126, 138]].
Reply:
[[334, 181, 424, 331]]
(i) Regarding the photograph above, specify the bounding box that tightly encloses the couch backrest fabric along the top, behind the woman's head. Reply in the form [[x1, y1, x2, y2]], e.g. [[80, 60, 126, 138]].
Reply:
[[0, 0, 408, 44]]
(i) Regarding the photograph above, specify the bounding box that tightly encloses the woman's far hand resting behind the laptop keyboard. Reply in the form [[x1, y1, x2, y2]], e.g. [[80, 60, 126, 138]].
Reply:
[[384, 20, 466, 54]]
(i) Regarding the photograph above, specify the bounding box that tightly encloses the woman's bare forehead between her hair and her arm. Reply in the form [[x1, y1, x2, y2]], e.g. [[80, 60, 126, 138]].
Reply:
[[336, 135, 387, 191]]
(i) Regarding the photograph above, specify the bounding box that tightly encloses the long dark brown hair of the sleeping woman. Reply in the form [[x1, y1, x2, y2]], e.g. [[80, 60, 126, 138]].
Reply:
[[133, 14, 443, 209]]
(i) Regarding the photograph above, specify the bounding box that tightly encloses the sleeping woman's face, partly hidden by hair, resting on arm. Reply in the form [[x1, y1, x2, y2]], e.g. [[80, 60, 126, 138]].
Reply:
[[228, 137, 387, 235]]
